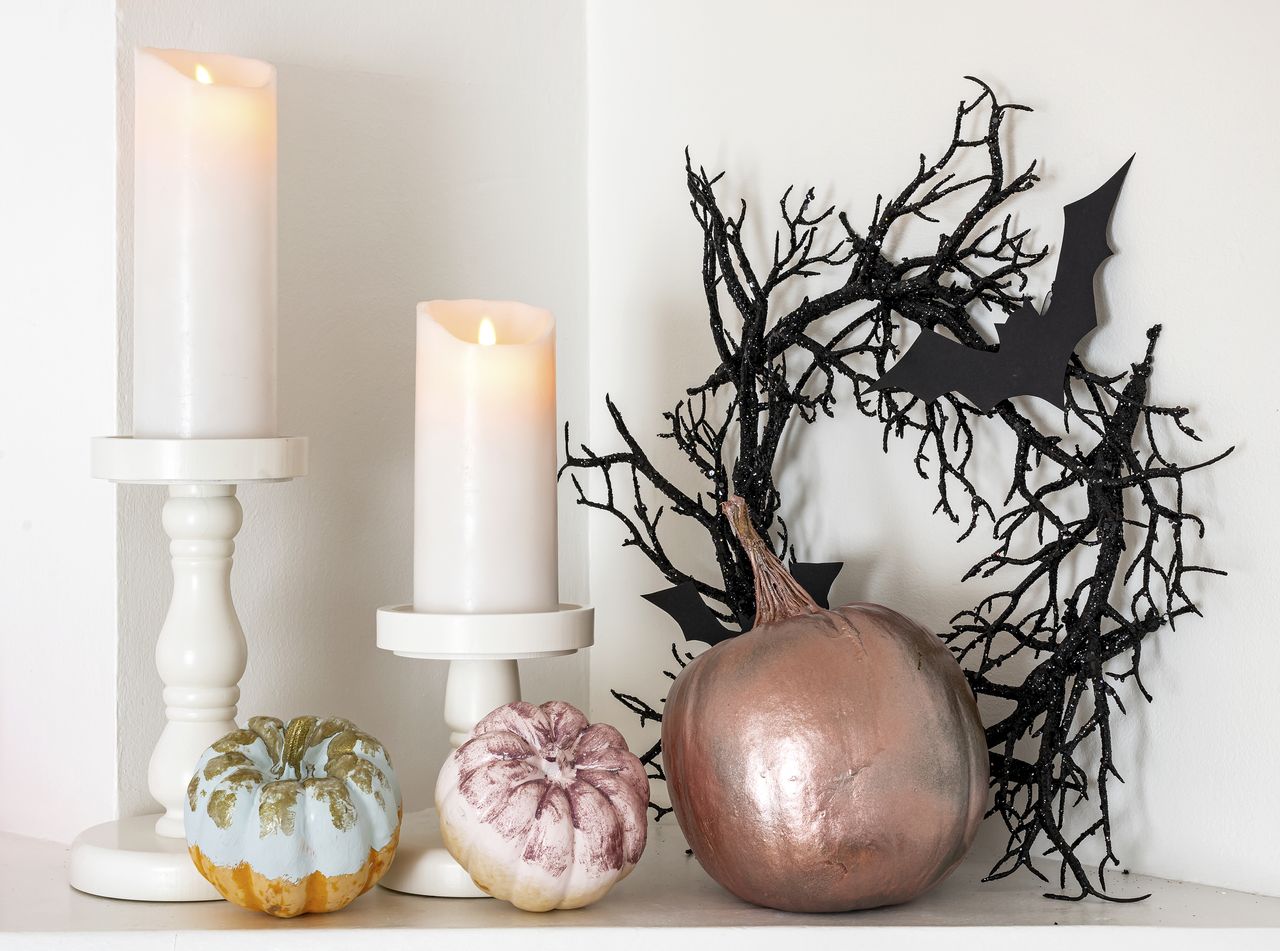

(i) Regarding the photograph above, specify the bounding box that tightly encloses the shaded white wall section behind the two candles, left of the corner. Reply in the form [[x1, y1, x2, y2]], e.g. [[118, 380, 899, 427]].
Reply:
[[119, 0, 586, 814]]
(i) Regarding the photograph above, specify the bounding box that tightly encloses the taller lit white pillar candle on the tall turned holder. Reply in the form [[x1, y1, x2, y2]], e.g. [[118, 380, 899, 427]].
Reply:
[[133, 50, 278, 438]]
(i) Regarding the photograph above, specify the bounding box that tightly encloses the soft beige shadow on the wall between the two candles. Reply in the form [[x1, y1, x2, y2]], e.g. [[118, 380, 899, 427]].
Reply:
[[244, 64, 435, 805]]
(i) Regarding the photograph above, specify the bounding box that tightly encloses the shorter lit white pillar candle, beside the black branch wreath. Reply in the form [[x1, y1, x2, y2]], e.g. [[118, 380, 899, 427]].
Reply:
[[413, 301, 558, 613]]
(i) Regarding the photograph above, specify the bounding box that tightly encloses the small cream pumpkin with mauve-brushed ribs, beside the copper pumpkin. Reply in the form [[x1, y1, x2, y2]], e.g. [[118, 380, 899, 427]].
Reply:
[[435, 700, 649, 911]]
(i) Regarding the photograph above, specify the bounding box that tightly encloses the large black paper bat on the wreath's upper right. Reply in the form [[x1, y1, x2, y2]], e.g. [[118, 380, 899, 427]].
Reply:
[[872, 156, 1133, 412]]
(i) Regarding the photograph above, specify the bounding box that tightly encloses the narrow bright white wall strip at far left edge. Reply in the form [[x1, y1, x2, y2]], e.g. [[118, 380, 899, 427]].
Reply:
[[0, 0, 116, 838]]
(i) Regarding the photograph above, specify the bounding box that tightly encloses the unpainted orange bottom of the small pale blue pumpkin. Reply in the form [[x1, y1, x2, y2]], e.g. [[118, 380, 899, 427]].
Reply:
[[188, 828, 399, 918]]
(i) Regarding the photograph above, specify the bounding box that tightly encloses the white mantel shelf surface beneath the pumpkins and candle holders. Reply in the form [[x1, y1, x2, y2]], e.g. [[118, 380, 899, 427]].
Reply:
[[0, 823, 1280, 951]]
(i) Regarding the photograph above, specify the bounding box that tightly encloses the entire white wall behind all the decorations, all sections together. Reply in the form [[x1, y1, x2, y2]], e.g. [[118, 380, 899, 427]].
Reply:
[[0, 0, 1280, 893]]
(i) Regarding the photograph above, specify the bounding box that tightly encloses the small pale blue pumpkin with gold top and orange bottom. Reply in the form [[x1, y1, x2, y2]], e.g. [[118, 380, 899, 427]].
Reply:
[[184, 717, 401, 918]]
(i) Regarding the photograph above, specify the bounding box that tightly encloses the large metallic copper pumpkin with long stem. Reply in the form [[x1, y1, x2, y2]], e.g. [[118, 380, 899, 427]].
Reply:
[[662, 499, 987, 911]]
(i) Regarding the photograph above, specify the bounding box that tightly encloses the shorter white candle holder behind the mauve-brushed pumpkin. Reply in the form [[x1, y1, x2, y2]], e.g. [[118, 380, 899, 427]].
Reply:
[[368, 604, 595, 899]]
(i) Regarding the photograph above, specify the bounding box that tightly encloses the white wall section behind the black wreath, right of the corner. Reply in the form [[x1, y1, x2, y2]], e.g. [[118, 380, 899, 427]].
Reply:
[[588, 0, 1280, 893]]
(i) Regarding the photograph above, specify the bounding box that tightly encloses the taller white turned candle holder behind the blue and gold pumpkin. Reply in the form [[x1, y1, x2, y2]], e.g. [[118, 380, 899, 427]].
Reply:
[[69, 436, 307, 901]]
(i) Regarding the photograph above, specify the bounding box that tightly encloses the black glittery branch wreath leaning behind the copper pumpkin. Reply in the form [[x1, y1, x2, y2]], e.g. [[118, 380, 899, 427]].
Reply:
[[562, 79, 1230, 899]]
